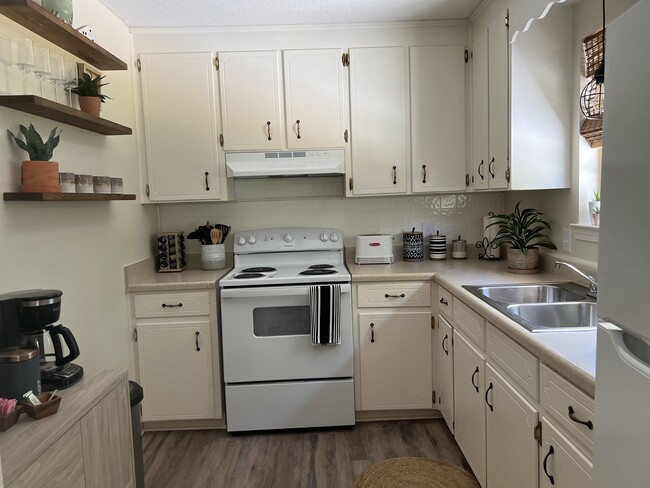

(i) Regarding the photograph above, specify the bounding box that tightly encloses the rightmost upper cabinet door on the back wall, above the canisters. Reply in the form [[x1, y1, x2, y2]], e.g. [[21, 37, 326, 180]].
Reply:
[[409, 46, 465, 192]]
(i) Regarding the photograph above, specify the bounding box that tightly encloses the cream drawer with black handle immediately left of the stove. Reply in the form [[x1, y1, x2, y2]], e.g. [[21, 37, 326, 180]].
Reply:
[[133, 291, 211, 319]]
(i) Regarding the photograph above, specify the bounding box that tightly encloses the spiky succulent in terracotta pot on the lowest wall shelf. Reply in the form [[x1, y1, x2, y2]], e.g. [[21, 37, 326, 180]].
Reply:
[[7, 124, 61, 193]]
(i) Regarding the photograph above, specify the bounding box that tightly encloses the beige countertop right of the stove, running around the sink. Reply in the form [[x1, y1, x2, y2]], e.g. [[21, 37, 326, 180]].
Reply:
[[346, 252, 596, 397]]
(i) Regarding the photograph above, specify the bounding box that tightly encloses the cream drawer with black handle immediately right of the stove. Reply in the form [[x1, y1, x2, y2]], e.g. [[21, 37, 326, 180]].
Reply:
[[357, 281, 431, 308]]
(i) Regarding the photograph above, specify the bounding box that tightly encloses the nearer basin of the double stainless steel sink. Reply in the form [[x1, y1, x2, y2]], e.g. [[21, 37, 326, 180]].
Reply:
[[507, 302, 598, 332]]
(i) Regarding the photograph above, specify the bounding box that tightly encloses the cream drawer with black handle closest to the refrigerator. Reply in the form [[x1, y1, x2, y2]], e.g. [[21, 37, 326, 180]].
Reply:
[[540, 364, 592, 452]]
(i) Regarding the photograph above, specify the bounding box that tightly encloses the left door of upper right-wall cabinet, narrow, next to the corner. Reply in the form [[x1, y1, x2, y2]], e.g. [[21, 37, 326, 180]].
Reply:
[[472, 26, 490, 190]]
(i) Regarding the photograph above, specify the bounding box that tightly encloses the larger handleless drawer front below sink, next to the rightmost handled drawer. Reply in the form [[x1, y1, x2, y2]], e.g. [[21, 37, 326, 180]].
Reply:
[[485, 322, 539, 400]]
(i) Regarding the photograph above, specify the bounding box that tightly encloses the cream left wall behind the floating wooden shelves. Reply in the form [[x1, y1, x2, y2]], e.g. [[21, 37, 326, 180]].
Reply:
[[0, 0, 157, 372]]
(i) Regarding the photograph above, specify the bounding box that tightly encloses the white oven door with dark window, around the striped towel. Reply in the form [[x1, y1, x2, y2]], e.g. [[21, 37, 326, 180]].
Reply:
[[221, 284, 353, 383]]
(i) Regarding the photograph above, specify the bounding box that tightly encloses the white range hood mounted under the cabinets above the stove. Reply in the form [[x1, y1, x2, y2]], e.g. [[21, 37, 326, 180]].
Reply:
[[226, 149, 345, 178]]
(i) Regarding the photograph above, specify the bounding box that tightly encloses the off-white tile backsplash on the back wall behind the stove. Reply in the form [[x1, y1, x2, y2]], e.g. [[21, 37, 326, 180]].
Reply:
[[160, 188, 503, 253]]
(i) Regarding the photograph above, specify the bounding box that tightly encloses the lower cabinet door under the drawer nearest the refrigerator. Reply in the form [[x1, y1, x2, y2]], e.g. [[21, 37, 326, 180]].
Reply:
[[539, 417, 593, 488]]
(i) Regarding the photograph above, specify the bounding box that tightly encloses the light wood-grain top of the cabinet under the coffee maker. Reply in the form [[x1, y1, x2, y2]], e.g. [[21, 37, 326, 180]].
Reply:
[[0, 370, 127, 485]]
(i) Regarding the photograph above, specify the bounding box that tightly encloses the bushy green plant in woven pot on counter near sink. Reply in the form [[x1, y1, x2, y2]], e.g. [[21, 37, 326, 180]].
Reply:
[[486, 202, 557, 273]]
